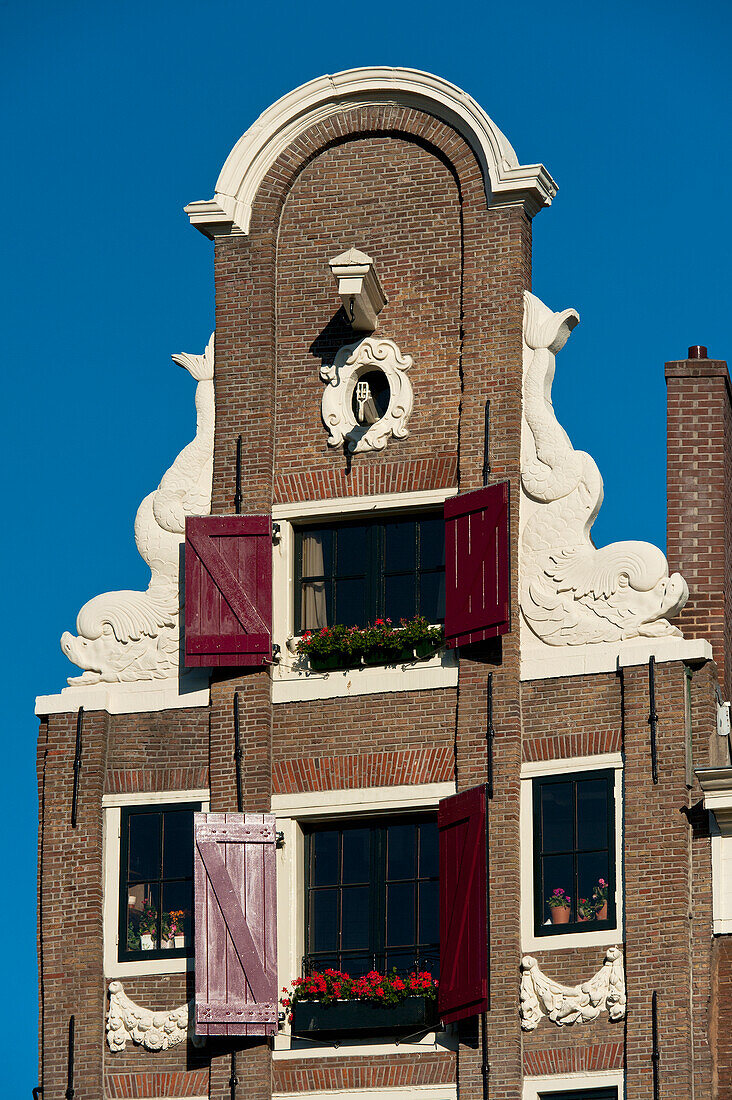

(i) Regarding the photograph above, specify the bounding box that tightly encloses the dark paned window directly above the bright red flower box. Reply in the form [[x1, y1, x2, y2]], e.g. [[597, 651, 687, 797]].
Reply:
[[304, 816, 439, 976]]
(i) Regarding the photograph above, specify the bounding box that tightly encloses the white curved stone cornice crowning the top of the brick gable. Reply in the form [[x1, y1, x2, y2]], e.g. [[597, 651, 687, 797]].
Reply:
[[185, 67, 557, 237]]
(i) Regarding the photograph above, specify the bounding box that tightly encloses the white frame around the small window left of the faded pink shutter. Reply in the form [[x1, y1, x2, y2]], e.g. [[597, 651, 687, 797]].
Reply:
[[101, 788, 210, 978]]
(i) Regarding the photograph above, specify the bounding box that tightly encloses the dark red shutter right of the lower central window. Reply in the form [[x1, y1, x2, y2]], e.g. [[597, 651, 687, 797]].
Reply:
[[437, 787, 488, 1023]]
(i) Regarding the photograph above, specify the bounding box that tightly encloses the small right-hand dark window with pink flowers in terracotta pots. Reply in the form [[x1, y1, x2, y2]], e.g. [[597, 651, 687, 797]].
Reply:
[[533, 770, 615, 936]]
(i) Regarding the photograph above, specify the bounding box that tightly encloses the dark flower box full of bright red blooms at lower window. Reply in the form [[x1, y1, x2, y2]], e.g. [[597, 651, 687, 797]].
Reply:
[[282, 968, 438, 1036]]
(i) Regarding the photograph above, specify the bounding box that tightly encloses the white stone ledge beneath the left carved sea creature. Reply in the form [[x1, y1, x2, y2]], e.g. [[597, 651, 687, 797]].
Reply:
[[35, 669, 210, 715]]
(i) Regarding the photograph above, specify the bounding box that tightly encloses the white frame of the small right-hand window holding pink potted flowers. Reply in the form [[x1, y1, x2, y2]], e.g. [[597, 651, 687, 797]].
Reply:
[[521, 752, 623, 952]]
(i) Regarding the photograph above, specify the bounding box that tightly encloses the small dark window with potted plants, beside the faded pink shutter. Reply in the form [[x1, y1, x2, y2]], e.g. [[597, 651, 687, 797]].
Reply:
[[118, 802, 200, 961]]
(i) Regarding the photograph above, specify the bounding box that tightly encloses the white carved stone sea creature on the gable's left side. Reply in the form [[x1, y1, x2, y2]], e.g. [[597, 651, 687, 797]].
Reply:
[[61, 336, 215, 684]]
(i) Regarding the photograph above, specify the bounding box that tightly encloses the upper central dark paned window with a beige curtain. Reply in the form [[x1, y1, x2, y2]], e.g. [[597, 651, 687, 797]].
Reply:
[[295, 514, 445, 634]]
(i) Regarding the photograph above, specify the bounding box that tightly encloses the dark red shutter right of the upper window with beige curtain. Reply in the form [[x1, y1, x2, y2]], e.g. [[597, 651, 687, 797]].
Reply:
[[445, 482, 511, 647]]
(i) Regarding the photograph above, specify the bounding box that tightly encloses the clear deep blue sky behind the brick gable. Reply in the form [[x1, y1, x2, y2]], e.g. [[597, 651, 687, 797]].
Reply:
[[0, 0, 732, 1096]]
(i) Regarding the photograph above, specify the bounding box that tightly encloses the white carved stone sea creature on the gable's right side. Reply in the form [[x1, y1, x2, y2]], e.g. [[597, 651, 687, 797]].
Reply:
[[520, 293, 689, 646]]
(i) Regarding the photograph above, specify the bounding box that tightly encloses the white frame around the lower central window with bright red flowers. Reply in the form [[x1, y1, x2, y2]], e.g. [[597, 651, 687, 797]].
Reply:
[[272, 782, 455, 1056]]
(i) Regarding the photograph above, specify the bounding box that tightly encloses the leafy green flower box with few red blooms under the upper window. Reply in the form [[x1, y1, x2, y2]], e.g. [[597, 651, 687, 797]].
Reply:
[[295, 615, 445, 671]]
